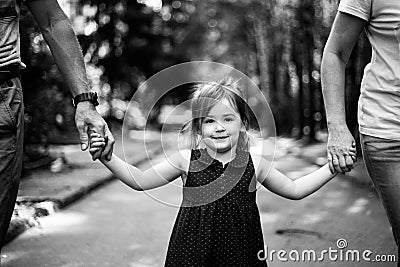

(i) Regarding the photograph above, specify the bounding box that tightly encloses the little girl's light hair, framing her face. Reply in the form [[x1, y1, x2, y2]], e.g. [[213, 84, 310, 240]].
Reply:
[[181, 78, 250, 151]]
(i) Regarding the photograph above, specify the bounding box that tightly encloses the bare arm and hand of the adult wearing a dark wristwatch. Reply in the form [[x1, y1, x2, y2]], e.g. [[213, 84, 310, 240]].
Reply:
[[25, 0, 114, 159]]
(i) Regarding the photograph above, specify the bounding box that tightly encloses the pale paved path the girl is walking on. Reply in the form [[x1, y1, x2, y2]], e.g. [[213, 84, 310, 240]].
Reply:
[[2, 146, 395, 267]]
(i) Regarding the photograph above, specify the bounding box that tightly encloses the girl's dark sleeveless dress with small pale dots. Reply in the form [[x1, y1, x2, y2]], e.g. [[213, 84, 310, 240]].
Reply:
[[165, 149, 267, 267]]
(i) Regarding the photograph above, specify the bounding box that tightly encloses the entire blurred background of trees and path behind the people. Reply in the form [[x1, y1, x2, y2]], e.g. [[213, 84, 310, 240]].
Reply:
[[4, 0, 397, 267]]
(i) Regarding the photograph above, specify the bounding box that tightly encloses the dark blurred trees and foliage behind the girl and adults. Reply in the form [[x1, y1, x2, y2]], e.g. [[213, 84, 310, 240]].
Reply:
[[21, 0, 370, 168]]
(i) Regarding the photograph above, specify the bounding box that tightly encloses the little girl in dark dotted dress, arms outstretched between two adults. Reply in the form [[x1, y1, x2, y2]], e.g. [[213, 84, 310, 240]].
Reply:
[[90, 80, 355, 267]]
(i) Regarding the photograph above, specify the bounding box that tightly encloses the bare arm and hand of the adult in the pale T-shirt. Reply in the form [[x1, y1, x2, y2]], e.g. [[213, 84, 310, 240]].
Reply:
[[321, 12, 366, 173]]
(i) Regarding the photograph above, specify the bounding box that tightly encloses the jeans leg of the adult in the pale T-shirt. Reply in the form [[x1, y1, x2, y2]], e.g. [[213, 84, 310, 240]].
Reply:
[[360, 134, 400, 262]]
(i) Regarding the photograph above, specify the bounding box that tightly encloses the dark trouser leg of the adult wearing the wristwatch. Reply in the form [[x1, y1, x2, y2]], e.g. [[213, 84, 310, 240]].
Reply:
[[0, 78, 24, 250]]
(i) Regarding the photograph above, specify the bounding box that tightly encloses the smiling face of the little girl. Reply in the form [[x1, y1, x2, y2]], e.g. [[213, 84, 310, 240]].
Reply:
[[201, 99, 245, 153]]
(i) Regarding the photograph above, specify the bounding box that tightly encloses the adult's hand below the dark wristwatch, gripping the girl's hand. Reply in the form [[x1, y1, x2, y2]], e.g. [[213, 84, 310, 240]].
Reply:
[[75, 101, 115, 160]]
